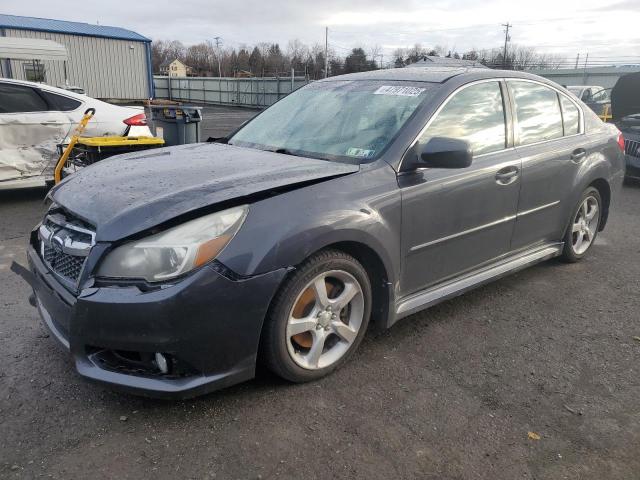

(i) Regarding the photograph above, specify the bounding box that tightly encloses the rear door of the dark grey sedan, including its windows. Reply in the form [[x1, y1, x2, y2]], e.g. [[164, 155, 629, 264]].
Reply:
[[507, 79, 590, 249]]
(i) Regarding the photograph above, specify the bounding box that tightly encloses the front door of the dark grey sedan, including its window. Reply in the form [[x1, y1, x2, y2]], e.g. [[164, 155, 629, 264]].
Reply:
[[398, 80, 521, 296]]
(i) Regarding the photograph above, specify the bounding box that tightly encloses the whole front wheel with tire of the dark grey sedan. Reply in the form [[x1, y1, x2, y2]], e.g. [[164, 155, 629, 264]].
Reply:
[[260, 250, 371, 382]]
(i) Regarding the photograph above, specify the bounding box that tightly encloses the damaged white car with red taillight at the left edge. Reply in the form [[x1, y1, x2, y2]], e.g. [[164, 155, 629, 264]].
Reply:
[[0, 78, 152, 190]]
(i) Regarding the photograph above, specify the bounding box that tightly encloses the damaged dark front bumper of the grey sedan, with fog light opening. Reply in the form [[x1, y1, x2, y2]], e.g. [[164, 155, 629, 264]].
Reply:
[[16, 246, 286, 398]]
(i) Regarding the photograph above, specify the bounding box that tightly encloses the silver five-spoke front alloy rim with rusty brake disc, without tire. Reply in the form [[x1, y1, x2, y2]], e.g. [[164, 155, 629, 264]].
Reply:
[[286, 270, 365, 370]]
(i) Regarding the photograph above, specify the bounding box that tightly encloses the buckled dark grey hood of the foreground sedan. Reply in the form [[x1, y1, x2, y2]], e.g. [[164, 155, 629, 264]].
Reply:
[[50, 143, 360, 241]]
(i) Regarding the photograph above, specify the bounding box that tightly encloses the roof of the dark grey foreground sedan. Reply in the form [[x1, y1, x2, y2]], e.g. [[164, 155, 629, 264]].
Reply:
[[321, 66, 550, 83]]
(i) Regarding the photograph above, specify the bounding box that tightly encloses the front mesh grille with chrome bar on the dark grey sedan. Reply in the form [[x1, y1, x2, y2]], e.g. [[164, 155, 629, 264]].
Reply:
[[39, 211, 95, 288]]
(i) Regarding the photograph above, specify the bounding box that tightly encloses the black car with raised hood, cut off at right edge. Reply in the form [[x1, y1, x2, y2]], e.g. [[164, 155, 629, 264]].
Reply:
[[611, 73, 640, 180]]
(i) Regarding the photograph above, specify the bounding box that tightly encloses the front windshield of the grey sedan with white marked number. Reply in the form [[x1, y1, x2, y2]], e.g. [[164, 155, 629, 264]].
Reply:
[[229, 80, 433, 162]]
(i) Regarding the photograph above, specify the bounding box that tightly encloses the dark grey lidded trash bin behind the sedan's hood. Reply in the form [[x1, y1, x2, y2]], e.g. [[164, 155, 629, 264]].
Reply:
[[145, 105, 202, 146]]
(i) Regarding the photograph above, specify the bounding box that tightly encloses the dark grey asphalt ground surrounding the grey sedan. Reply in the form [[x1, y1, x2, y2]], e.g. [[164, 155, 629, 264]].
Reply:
[[0, 109, 640, 480]]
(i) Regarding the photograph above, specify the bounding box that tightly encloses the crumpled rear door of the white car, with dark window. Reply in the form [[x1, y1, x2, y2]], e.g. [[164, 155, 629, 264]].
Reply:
[[0, 82, 71, 182]]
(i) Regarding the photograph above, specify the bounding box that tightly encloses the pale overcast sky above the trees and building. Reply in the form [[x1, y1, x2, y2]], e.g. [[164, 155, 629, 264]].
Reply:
[[1, 0, 640, 63]]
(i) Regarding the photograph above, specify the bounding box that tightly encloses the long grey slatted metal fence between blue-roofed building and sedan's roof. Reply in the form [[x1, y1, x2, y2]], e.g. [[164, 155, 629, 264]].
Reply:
[[153, 76, 309, 108]]
